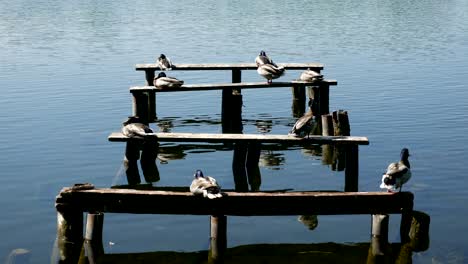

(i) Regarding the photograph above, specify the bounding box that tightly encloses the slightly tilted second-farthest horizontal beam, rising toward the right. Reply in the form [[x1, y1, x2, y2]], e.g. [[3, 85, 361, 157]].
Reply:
[[130, 80, 338, 93]]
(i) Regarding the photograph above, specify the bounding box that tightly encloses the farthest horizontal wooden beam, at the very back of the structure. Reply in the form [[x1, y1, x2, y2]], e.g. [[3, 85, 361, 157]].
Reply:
[[135, 62, 323, 71]]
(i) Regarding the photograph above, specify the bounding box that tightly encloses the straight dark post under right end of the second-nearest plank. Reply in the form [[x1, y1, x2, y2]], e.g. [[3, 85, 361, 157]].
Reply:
[[344, 145, 359, 192]]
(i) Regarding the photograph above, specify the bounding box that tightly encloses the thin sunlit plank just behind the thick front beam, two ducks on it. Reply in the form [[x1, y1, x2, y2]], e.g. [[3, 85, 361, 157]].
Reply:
[[108, 132, 369, 145]]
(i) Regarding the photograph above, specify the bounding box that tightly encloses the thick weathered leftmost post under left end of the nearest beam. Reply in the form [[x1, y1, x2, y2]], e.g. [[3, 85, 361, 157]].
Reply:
[[56, 204, 83, 263]]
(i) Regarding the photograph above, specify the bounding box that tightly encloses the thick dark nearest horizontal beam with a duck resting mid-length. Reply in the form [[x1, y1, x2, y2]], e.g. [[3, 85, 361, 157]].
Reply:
[[56, 188, 413, 216]]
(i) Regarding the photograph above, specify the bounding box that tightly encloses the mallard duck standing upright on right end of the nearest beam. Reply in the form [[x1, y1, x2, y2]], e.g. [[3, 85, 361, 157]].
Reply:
[[380, 148, 411, 192]]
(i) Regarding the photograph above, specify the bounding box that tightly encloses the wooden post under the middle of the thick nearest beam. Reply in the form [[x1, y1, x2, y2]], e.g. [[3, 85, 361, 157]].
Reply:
[[208, 215, 227, 263]]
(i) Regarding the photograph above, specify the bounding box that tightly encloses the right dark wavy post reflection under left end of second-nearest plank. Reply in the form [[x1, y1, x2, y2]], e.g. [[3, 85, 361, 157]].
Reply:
[[140, 140, 160, 183]]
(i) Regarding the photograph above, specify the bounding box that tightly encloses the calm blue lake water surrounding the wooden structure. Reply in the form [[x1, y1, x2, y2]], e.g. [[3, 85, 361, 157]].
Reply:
[[0, 0, 468, 263]]
